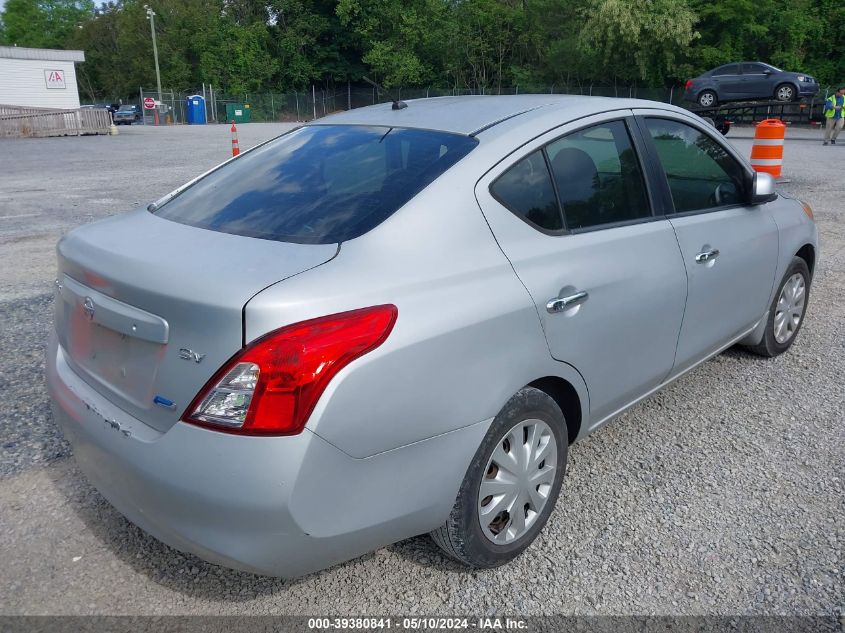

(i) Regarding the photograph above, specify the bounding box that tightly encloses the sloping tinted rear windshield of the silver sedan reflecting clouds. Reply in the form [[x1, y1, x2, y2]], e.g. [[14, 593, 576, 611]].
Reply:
[[154, 125, 478, 244]]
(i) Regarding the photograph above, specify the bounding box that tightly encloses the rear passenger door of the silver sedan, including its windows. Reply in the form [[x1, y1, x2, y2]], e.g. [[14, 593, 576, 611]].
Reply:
[[476, 111, 686, 426]]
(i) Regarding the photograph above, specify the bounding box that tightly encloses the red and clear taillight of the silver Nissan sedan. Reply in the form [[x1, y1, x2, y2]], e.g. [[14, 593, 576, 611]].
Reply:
[[182, 305, 398, 435]]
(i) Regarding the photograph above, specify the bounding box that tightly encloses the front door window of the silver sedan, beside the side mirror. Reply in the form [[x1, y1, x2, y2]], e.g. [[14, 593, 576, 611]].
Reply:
[[645, 119, 746, 213]]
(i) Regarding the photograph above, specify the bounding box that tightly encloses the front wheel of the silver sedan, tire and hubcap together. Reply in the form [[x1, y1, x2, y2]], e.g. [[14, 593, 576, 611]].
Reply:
[[748, 257, 810, 358]]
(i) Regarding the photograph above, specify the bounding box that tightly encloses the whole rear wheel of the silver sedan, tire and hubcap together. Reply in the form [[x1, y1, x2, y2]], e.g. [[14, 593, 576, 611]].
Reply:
[[431, 387, 568, 567]]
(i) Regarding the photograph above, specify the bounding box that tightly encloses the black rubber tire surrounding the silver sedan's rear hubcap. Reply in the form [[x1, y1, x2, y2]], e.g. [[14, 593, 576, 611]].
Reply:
[[431, 387, 568, 568]]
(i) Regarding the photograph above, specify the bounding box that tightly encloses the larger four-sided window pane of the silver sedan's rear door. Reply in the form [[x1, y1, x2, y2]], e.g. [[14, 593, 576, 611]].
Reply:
[[546, 121, 651, 230]]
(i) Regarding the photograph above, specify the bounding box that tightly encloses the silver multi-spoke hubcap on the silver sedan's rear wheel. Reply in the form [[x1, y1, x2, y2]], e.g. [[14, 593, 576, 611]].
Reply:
[[478, 420, 557, 545]]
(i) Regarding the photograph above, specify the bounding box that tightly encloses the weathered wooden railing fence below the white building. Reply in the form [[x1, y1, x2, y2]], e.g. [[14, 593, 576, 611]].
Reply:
[[0, 105, 111, 138]]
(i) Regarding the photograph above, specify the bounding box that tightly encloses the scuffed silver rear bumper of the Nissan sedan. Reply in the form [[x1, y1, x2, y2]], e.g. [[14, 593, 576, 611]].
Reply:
[[47, 336, 490, 577]]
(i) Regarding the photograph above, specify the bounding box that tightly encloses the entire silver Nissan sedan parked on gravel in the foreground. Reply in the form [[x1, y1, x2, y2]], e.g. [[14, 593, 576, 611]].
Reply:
[[47, 95, 817, 577]]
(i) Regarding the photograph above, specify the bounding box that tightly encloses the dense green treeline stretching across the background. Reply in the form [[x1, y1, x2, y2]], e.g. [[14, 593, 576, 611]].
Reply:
[[0, 0, 845, 100]]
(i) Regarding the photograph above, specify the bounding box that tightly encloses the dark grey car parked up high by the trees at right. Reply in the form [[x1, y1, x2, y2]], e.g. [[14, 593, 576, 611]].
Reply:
[[684, 62, 819, 108]]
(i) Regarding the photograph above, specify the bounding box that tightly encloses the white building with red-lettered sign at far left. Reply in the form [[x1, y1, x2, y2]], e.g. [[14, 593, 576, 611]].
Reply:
[[0, 46, 85, 109]]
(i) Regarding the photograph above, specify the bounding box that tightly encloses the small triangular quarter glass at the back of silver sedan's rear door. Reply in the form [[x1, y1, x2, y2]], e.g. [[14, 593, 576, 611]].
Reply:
[[490, 150, 563, 231]]
